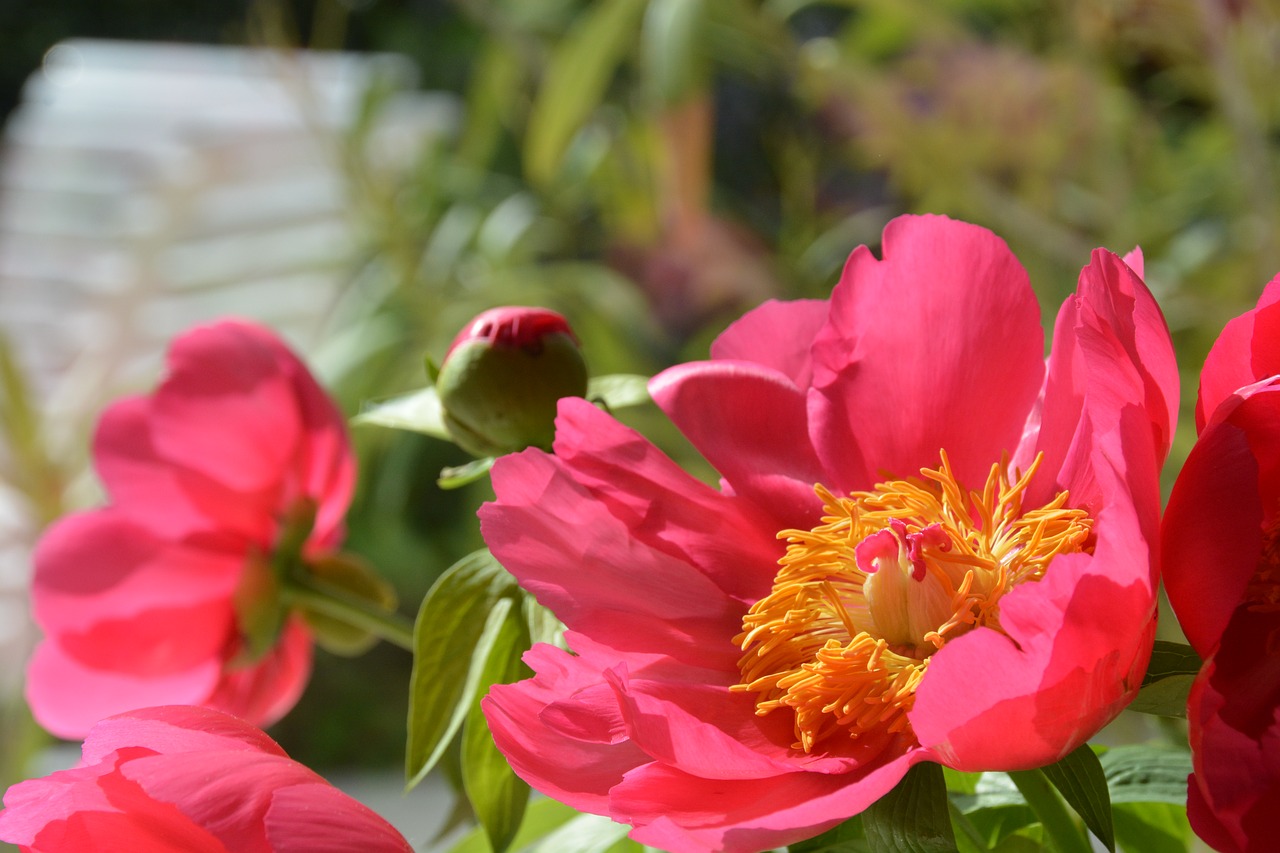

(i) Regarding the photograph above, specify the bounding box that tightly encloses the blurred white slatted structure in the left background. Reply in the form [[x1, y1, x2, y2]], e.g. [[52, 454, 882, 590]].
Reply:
[[0, 41, 454, 727]]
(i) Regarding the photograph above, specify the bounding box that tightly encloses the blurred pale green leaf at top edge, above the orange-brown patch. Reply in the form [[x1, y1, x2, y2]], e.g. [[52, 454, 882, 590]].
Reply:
[[641, 0, 707, 108]]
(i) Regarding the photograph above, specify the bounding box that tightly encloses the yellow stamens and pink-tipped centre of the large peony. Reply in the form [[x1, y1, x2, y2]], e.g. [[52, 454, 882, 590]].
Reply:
[[732, 452, 1092, 752]]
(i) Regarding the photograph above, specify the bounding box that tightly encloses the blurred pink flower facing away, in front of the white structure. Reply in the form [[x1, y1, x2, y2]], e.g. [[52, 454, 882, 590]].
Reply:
[[27, 321, 355, 738]]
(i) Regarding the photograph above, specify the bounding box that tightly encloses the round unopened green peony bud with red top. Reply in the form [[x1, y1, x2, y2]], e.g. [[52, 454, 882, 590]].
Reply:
[[435, 306, 586, 456]]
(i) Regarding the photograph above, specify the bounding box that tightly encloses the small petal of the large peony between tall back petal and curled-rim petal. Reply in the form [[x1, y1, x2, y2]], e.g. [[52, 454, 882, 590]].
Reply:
[[712, 294, 829, 389]]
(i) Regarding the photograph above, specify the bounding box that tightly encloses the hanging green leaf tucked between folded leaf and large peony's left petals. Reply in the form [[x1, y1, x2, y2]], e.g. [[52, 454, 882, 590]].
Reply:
[[462, 598, 532, 853]]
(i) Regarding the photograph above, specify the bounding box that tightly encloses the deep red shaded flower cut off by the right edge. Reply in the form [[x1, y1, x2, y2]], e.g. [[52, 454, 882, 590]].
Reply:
[[1161, 277, 1280, 852]]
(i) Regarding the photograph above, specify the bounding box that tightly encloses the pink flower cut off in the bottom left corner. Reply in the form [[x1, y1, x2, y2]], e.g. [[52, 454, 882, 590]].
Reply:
[[0, 706, 412, 853]]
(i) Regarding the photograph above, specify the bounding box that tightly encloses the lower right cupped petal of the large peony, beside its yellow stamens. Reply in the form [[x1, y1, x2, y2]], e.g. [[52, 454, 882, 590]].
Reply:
[[909, 458, 1156, 770]]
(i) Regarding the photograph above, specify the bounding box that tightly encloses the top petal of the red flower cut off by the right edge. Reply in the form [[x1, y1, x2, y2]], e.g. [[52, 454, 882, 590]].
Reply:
[[1196, 275, 1280, 430]]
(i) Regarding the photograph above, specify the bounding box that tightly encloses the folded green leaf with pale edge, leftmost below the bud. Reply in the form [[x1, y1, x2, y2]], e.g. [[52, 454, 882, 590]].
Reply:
[[404, 549, 518, 788]]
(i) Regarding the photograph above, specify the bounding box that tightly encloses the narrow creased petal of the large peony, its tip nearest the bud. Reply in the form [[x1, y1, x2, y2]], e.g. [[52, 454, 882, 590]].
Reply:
[[556, 397, 778, 602]]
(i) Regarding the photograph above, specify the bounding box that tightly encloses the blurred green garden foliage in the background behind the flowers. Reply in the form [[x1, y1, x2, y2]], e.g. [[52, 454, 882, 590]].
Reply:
[[0, 0, 1280, 845]]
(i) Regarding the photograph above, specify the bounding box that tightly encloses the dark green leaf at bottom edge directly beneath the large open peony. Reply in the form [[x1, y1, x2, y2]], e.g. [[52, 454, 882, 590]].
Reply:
[[863, 762, 957, 853]]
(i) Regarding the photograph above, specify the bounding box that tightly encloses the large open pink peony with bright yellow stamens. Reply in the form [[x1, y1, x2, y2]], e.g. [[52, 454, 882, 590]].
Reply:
[[480, 216, 1178, 850]]
